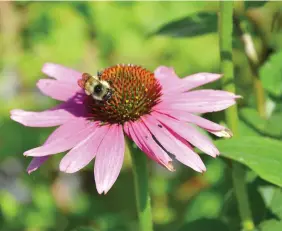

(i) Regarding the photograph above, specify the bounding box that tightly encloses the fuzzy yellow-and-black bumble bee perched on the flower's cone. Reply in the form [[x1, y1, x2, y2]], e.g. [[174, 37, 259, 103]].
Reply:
[[78, 73, 113, 102]]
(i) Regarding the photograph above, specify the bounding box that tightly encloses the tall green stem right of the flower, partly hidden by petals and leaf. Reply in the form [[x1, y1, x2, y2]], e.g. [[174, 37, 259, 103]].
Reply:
[[219, 1, 254, 231]]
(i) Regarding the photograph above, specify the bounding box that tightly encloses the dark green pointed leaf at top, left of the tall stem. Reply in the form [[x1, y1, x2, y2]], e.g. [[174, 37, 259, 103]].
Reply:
[[153, 12, 217, 37]]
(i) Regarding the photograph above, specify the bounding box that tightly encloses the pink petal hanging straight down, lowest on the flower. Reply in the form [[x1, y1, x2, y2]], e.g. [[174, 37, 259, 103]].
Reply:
[[94, 125, 125, 194]]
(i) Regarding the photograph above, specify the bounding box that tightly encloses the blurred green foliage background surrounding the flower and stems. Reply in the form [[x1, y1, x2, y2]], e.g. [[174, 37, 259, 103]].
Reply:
[[0, 1, 282, 231]]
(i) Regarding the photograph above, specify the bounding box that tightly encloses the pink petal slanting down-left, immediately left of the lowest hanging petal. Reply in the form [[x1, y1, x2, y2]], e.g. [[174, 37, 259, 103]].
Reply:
[[60, 126, 109, 173]]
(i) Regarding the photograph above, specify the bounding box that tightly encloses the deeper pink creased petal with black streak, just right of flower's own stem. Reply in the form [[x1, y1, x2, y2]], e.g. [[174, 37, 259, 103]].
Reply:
[[124, 122, 174, 171]]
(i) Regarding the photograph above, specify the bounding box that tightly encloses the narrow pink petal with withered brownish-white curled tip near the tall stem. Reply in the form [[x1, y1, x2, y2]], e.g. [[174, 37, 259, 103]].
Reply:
[[155, 110, 233, 138]]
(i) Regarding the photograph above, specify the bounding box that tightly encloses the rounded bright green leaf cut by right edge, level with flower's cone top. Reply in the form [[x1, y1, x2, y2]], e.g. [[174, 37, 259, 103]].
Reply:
[[259, 52, 282, 97]]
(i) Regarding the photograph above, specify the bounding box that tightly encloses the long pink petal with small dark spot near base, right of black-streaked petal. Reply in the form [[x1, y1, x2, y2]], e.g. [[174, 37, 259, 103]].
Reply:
[[142, 116, 206, 172]]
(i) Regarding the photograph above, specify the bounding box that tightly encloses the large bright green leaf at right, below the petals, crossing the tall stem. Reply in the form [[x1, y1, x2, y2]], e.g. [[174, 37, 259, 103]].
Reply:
[[216, 137, 282, 186]]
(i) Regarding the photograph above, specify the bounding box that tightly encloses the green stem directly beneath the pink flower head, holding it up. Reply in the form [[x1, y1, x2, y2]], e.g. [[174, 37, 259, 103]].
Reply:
[[127, 138, 153, 231]]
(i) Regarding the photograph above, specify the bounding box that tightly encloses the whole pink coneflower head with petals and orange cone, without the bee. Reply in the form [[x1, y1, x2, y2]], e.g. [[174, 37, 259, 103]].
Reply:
[[11, 63, 238, 193]]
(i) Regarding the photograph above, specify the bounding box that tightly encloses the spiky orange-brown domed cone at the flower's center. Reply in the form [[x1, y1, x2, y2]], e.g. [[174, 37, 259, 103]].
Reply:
[[86, 64, 162, 124]]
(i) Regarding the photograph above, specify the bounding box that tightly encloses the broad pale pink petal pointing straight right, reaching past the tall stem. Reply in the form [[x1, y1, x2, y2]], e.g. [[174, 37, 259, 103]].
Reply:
[[158, 90, 239, 113]]
